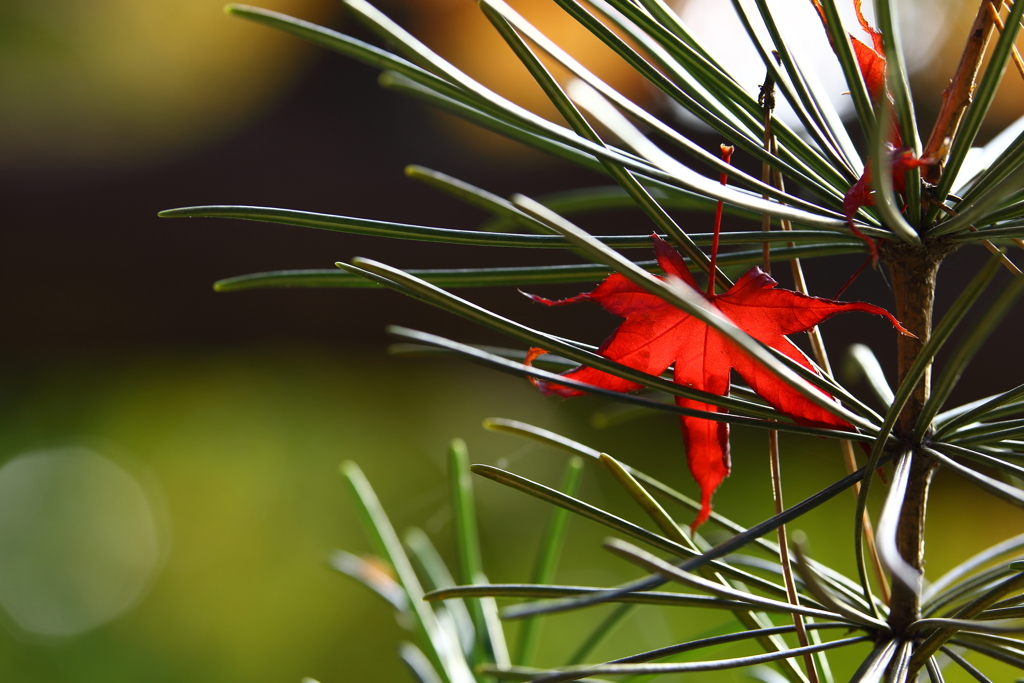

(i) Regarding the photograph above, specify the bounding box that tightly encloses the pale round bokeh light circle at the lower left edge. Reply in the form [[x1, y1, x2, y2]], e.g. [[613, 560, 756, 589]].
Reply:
[[0, 449, 167, 638]]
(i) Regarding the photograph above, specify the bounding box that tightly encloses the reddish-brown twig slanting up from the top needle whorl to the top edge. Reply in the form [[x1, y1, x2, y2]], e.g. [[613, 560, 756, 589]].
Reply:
[[922, 0, 1001, 183]]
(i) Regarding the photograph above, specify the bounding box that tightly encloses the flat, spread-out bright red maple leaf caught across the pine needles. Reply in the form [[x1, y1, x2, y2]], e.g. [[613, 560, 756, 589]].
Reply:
[[526, 237, 909, 528]]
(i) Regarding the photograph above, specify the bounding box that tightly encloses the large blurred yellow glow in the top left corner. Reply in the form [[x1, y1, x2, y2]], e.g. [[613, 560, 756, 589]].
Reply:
[[0, 0, 337, 167]]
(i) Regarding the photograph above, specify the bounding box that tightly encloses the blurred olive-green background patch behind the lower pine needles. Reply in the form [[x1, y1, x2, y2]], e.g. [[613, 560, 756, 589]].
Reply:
[[0, 346, 1024, 683]]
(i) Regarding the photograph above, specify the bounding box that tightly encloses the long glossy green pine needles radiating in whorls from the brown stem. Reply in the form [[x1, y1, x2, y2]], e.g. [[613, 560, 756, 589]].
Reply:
[[162, 0, 1024, 683]]
